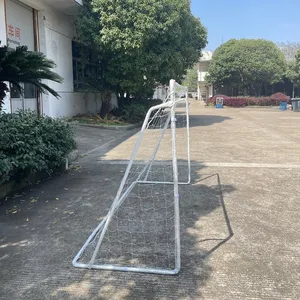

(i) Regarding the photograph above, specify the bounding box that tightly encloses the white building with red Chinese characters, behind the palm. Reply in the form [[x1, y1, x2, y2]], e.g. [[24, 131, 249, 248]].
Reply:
[[0, 0, 111, 118]]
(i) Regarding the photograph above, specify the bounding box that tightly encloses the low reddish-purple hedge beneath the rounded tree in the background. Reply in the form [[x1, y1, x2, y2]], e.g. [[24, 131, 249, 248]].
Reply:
[[207, 93, 290, 107]]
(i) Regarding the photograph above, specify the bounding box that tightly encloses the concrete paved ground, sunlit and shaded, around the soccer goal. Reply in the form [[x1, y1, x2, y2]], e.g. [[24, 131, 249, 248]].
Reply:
[[0, 102, 300, 300]]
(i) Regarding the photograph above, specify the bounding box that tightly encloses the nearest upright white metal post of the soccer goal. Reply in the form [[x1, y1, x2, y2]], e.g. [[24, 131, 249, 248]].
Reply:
[[170, 80, 181, 271]]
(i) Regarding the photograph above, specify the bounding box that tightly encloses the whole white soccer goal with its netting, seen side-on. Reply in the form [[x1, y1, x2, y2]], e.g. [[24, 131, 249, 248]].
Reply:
[[73, 80, 191, 275]]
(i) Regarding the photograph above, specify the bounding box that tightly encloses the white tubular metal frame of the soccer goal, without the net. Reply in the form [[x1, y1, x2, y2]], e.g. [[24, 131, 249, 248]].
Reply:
[[72, 80, 191, 275]]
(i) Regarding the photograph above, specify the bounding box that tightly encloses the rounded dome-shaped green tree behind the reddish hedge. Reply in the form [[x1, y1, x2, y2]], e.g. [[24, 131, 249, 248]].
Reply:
[[207, 39, 286, 95]]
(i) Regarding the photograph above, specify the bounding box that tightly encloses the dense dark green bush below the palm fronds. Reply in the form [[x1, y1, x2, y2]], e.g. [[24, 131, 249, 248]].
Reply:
[[0, 111, 76, 184]]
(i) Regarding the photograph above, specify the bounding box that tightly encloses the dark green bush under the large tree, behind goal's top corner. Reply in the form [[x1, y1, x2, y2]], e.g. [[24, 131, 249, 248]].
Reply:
[[122, 99, 162, 123]]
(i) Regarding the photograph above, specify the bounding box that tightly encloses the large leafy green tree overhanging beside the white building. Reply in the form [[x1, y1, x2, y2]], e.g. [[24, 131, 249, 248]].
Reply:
[[76, 0, 207, 105]]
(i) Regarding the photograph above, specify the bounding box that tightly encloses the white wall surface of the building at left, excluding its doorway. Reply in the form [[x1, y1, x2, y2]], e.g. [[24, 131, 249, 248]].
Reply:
[[0, 0, 104, 118]]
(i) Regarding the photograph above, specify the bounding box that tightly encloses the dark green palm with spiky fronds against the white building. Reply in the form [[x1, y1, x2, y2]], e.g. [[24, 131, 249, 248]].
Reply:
[[0, 46, 63, 111]]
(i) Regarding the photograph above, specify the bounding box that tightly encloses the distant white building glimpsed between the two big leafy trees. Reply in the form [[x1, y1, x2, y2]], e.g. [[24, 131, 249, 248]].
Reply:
[[197, 51, 213, 101]]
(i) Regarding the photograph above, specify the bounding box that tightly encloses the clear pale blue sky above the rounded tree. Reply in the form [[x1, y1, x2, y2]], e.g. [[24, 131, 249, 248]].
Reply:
[[191, 0, 300, 50]]
